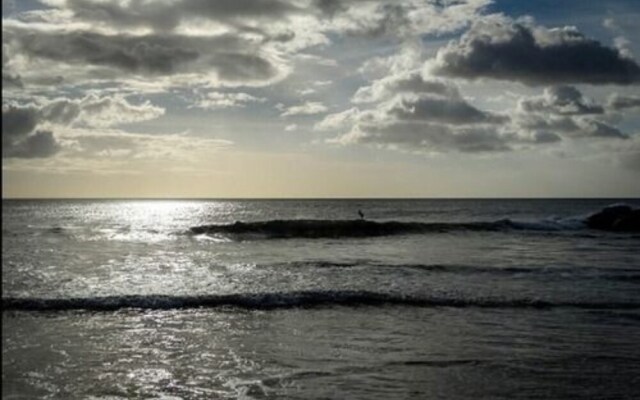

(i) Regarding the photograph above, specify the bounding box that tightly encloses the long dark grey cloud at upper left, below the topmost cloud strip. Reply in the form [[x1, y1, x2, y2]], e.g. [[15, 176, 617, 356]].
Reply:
[[4, 28, 277, 81]]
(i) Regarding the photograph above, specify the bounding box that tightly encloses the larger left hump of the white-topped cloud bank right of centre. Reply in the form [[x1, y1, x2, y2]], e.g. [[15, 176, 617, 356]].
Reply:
[[315, 71, 512, 153]]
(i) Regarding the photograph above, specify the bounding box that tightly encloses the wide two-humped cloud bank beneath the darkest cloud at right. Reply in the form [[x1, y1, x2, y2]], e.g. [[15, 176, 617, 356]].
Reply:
[[315, 71, 629, 153]]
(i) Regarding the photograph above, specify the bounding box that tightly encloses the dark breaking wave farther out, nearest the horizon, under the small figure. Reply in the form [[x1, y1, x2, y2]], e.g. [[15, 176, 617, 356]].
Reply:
[[190, 219, 584, 238]]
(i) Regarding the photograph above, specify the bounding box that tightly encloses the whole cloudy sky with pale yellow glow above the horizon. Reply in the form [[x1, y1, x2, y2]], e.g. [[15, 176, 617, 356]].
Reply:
[[2, 0, 640, 198]]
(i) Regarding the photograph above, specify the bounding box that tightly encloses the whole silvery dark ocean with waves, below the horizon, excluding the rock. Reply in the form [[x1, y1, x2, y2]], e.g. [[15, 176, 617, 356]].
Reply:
[[2, 199, 640, 399]]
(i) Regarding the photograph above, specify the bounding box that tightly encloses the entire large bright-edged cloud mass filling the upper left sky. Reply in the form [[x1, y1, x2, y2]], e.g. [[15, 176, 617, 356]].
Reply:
[[3, 0, 490, 91]]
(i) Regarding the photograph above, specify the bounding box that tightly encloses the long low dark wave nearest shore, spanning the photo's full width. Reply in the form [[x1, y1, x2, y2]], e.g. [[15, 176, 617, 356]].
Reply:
[[2, 291, 640, 311]]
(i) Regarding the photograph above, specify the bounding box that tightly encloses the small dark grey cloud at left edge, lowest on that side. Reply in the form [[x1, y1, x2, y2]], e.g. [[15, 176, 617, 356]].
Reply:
[[2, 106, 60, 158]]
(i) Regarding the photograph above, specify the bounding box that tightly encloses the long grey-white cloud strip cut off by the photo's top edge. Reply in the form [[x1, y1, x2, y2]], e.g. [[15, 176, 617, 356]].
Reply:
[[57, 0, 491, 37]]
